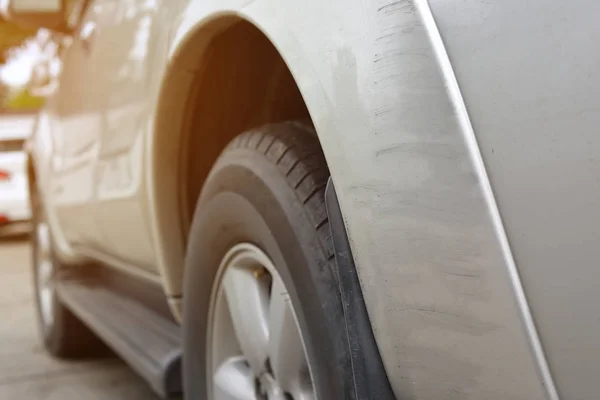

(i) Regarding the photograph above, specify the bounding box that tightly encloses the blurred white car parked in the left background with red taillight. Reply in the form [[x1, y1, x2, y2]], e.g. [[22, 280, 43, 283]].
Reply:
[[0, 113, 35, 234]]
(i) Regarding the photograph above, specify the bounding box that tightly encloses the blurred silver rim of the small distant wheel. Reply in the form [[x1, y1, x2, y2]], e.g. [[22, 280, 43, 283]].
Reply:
[[35, 222, 54, 330]]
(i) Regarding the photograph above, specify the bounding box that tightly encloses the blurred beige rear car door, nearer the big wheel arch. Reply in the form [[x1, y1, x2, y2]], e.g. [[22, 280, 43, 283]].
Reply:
[[88, 0, 168, 273]]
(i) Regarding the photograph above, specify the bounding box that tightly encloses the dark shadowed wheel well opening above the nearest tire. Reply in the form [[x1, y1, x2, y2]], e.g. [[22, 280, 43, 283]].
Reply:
[[151, 15, 310, 296]]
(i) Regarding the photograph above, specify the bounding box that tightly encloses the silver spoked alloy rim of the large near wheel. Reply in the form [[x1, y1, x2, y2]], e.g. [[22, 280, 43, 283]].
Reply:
[[207, 243, 316, 400]]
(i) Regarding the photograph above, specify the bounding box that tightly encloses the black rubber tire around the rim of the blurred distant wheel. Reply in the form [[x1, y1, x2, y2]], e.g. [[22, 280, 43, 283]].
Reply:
[[31, 188, 108, 359]]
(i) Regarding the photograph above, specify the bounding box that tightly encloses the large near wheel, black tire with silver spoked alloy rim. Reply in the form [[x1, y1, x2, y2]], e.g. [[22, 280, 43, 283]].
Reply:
[[183, 123, 353, 400]]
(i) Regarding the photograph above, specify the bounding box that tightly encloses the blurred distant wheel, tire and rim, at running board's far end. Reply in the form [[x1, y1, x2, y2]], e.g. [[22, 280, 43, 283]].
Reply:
[[31, 189, 106, 358]]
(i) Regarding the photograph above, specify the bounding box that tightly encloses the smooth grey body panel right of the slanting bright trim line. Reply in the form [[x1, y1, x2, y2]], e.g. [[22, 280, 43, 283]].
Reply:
[[431, 0, 600, 399]]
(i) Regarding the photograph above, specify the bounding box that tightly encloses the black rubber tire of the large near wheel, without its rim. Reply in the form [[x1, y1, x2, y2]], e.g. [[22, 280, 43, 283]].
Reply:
[[183, 122, 354, 400]]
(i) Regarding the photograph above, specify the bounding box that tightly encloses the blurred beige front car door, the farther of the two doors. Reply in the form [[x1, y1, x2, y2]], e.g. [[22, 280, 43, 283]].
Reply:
[[46, 1, 105, 248]]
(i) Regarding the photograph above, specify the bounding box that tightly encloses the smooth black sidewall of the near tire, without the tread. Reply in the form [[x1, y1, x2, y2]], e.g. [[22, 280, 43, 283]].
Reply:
[[184, 158, 347, 399]]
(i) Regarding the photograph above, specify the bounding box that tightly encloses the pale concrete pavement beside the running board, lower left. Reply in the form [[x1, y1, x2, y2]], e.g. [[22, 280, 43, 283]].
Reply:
[[0, 238, 157, 400]]
